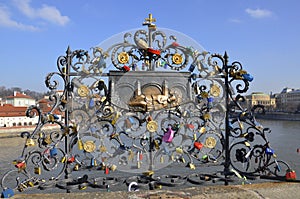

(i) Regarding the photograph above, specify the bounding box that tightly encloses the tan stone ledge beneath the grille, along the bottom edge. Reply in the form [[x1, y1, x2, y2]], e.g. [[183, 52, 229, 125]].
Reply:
[[12, 182, 300, 199]]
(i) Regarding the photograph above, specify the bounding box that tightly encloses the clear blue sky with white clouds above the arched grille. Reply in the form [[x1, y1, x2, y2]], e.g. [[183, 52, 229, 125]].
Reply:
[[0, 0, 300, 93]]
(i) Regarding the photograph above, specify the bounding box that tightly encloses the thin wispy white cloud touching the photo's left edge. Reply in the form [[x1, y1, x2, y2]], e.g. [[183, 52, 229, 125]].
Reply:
[[0, 5, 39, 31]]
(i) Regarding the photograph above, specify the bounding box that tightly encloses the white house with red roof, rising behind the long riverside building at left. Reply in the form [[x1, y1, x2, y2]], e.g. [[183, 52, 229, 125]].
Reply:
[[6, 91, 35, 107]]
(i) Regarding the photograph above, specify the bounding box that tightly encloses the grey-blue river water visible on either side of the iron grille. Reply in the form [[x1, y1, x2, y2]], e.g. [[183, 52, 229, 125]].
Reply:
[[0, 120, 300, 192]]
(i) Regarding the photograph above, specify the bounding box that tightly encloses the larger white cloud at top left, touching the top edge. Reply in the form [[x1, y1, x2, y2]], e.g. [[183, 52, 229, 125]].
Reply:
[[14, 0, 70, 26]]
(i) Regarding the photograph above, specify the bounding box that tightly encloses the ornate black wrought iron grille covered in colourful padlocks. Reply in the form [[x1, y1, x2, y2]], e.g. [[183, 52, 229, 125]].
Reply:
[[1, 15, 289, 197]]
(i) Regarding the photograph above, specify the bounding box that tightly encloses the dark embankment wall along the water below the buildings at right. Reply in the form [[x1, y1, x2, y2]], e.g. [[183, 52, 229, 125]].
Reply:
[[255, 112, 300, 121]]
